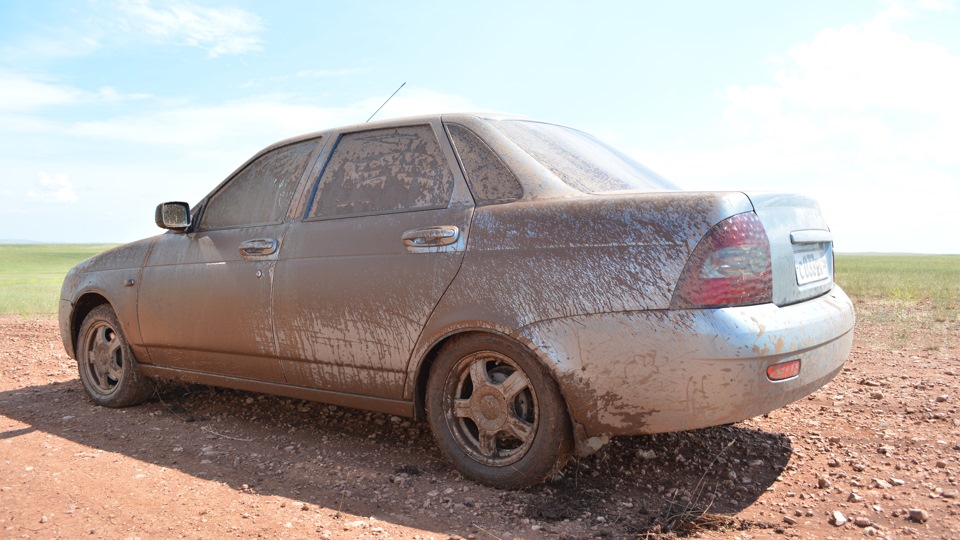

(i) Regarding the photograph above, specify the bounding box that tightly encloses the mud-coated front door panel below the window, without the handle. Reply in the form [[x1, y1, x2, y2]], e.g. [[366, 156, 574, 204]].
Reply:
[[139, 224, 286, 382]]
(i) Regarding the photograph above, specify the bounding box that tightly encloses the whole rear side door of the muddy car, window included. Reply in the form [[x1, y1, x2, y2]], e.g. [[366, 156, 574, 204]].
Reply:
[[274, 119, 473, 399]]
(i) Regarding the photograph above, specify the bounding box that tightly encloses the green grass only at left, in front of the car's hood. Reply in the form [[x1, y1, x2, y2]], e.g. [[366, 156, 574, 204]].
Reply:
[[0, 244, 113, 315]]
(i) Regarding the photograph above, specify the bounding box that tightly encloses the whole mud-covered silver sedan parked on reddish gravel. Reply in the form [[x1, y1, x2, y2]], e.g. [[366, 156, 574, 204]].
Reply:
[[59, 114, 854, 488]]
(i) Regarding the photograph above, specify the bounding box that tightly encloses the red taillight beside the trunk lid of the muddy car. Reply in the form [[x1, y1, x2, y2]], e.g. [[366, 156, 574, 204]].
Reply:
[[671, 212, 773, 309]]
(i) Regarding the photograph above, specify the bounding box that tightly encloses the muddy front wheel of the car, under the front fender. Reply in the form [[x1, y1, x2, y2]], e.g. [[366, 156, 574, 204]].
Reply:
[[77, 304, 153, 407]]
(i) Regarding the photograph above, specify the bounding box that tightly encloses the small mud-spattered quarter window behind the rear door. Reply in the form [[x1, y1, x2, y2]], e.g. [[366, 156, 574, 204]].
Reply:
[[447, 124, 523, 206]]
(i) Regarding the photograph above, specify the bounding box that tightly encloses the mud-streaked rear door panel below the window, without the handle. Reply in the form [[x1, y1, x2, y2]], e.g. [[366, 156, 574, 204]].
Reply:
[[275, 205, 473, 398]]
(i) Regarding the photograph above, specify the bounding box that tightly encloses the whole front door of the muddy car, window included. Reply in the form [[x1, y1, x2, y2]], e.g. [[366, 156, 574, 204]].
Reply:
[[138, 138, 320, 382]]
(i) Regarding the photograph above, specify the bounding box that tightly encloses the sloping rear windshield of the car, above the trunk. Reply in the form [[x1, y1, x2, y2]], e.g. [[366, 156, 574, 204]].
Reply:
[[493, 120, 680, 193]]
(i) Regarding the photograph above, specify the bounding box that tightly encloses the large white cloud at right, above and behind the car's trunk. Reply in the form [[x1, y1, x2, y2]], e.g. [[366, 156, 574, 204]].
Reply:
[[644, 3, 960, 253]]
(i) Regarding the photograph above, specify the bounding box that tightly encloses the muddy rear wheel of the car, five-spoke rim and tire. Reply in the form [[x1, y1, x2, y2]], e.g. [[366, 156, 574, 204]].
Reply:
[[426, 334, 572, 489]]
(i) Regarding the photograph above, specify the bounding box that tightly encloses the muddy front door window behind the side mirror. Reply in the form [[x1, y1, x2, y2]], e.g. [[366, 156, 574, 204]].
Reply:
[[201, 139, 320, 229]]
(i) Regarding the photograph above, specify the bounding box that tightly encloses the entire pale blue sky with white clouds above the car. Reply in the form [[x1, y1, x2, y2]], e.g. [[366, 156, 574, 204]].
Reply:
[[0, 0, 960, 253]]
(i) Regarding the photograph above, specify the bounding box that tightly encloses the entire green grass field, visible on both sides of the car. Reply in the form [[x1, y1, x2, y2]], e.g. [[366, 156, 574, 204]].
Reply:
[[0, 244, 960, 321]]
